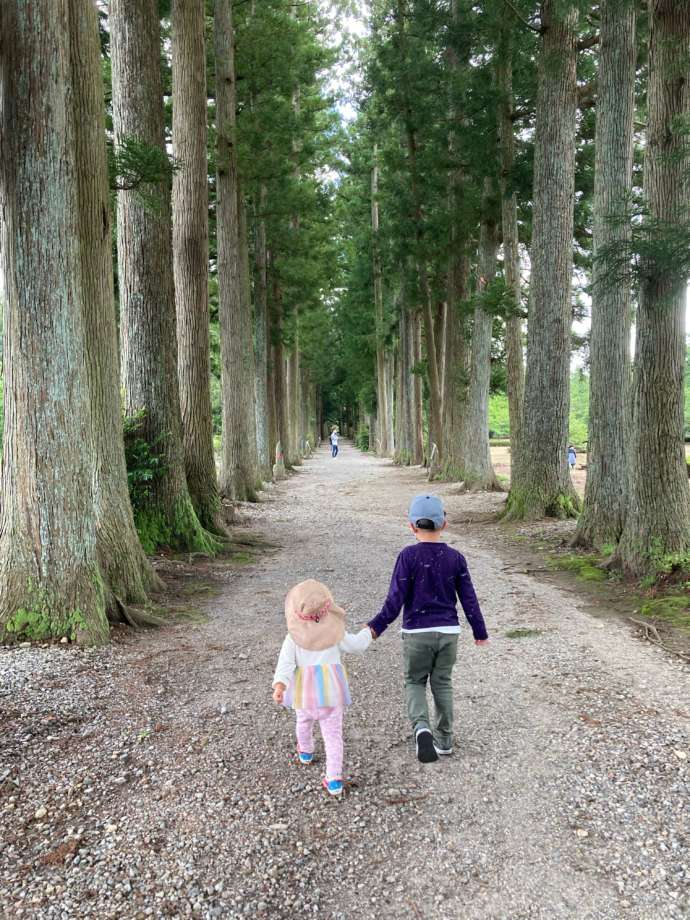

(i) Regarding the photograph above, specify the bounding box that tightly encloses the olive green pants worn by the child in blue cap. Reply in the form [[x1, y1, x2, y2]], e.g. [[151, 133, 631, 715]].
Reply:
[[403, 632, 458, 747]]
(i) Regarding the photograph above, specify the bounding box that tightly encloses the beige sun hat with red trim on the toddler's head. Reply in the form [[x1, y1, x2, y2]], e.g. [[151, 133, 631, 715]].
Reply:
[[285, 578, 345, 652]]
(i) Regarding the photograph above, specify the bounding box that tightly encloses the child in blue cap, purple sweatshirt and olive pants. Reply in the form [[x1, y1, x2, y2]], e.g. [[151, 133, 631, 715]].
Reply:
[[367, 495, 489, 763]]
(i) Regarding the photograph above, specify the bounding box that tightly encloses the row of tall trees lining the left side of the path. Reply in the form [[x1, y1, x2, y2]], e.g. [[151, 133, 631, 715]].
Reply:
[[0, 0, 335, 642]]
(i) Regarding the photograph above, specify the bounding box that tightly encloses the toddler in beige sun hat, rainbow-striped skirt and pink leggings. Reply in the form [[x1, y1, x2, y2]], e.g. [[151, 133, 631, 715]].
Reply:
[[273, 579, 372, 795]]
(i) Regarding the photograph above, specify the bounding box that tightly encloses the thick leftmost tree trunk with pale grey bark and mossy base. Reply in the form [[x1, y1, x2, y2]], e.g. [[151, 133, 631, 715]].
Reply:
[[0, 0, 108, 644]]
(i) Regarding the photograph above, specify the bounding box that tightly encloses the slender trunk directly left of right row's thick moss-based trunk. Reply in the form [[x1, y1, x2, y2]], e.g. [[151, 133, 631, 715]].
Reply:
[[497, 28, 525, 455]]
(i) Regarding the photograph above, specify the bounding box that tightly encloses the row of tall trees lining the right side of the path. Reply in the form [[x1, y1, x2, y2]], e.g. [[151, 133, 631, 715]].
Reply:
[[336, 0, 690, 573]]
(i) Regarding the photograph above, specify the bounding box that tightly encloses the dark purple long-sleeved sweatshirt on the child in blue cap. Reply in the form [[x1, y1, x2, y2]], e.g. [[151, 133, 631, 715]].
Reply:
[[368, 542, 488, 639]]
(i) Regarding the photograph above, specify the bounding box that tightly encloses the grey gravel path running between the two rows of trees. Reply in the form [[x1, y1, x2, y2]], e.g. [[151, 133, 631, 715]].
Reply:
[[0, 444, 690, 920]]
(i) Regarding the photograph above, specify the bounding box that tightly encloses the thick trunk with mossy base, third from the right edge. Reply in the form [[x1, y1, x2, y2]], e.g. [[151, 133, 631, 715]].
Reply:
[[507, 0, 579, 519]]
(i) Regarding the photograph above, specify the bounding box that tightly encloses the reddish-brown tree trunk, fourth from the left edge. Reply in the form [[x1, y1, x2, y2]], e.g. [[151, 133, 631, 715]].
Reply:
[[172, 0, 225, 533]]
